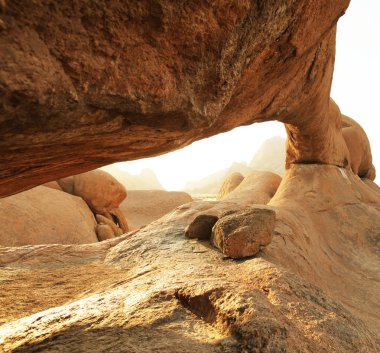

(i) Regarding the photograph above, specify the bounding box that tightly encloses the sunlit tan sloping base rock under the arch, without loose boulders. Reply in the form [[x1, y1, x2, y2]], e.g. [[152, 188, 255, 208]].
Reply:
[[0, 165, 380, 353]]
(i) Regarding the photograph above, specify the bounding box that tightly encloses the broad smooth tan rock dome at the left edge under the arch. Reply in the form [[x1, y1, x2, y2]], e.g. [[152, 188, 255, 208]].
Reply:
[[0, 186, 98, 246]]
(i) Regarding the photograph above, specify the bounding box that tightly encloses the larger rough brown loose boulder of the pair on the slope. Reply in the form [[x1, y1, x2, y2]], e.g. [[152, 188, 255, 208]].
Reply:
[[211, 207, 276, 259]]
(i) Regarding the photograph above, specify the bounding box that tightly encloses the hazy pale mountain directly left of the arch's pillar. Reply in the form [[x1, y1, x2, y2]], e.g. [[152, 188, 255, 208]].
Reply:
[[249, 136, 286, 176]]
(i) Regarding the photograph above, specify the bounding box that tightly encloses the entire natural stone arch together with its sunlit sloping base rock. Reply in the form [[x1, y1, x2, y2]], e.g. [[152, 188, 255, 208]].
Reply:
[[0, 0, 380, 353]]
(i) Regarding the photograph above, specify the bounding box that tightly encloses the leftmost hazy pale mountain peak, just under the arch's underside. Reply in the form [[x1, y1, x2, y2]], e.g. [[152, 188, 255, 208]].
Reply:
[[101, 164, 164, 190]]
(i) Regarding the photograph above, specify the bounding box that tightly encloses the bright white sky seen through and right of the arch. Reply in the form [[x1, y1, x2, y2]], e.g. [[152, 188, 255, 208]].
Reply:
[[117, 0, 380, 190]]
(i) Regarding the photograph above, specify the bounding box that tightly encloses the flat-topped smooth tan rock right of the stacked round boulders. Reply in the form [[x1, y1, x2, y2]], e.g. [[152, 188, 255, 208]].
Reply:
[[120, 190, 192, 230]]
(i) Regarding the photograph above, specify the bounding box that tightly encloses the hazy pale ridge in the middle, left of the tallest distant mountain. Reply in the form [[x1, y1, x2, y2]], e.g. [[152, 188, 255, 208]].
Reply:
[[183, 162, 252, 194]]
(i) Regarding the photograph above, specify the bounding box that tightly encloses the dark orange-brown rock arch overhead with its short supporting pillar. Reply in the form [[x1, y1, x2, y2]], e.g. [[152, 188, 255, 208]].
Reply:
[[0, 0, 349, 195]]
